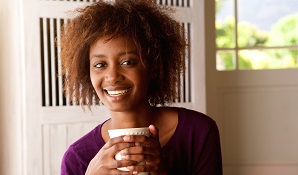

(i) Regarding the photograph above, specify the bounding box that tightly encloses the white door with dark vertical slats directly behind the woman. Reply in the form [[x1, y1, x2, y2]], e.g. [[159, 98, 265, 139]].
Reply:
[[23, 0, 205, 175]]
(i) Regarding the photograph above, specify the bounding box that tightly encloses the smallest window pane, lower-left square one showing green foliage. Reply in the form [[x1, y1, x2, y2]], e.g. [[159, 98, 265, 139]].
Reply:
[[216, 51, 236, 70]]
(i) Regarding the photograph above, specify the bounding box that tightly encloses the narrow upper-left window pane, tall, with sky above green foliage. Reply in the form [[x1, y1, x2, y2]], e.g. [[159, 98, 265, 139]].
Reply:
[[215, 0, 235, 48]]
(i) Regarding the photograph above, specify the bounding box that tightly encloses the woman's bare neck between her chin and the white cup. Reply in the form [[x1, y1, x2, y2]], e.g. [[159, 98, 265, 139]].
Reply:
[[108, 106, 157, 129]]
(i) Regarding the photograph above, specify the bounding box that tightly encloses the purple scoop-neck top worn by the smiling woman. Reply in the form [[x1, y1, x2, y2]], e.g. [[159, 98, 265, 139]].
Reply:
[[61, 108, 222, 175]]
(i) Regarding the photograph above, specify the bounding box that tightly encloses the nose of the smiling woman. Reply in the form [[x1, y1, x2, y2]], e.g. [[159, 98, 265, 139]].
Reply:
[[105, 65, 124, 84]]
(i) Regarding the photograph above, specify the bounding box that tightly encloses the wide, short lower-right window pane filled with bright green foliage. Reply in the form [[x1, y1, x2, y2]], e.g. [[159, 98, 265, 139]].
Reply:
[[239, 49, 298, 70]]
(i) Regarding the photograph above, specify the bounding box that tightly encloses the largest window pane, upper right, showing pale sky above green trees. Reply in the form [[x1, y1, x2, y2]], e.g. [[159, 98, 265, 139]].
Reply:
[[238, 0, 298, 47]]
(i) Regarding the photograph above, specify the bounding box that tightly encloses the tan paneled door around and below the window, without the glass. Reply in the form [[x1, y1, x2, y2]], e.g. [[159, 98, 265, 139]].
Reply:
[[206, 0, 298, 175]]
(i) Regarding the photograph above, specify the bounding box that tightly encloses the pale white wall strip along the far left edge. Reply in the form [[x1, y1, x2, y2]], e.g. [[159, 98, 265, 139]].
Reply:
[[0, 0, 23, 175]]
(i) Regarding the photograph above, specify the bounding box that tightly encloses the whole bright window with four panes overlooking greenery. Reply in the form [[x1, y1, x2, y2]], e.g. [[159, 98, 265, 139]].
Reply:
[[216, 0, 298, 71]]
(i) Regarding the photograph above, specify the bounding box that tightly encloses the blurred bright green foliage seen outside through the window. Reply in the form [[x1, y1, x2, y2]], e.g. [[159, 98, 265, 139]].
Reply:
[[216, 14, 298, 70]]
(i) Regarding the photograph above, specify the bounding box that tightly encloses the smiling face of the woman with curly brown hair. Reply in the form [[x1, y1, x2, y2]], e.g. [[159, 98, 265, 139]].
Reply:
[[89, 37, 149, 112]]
